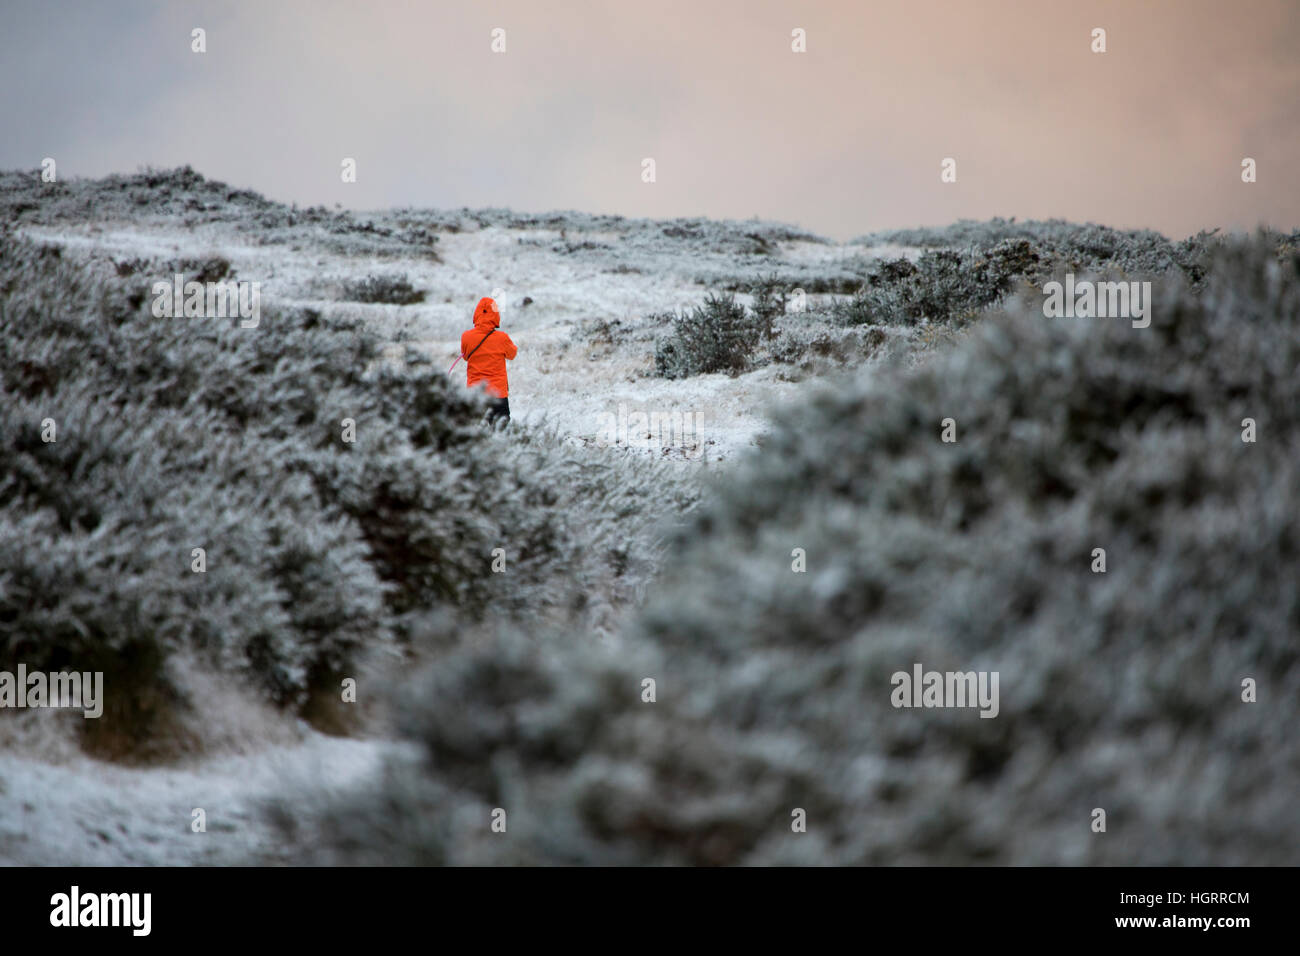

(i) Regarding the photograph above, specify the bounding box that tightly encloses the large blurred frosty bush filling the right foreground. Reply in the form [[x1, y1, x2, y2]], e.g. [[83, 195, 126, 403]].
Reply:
[[295, 234, 1300, 865]]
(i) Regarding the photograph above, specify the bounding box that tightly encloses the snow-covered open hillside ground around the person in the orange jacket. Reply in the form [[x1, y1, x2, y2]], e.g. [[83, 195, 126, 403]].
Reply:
[[23, 224, 913, 463]]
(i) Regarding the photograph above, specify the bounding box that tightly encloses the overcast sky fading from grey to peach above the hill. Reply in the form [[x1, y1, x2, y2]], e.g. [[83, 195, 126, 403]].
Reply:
[[0, 0, 1300, 238]]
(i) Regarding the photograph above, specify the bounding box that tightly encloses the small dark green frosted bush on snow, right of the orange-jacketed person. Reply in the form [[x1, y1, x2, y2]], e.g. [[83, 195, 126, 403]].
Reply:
[[654, 294, 763, 378]]
